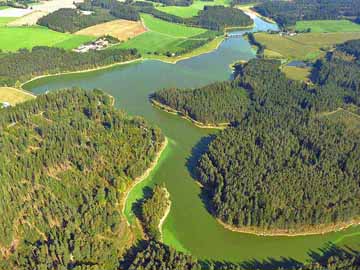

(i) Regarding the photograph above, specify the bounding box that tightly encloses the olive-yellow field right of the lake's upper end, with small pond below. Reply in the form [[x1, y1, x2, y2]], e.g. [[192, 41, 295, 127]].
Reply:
[[255, 32, 360, 61]]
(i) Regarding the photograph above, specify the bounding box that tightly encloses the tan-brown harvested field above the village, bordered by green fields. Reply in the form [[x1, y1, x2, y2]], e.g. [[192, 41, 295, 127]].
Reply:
[[75, 20, 146, 41]]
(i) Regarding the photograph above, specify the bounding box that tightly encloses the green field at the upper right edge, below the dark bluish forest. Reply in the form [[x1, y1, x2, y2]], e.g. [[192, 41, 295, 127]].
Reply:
[[295, 20, 360, 33]]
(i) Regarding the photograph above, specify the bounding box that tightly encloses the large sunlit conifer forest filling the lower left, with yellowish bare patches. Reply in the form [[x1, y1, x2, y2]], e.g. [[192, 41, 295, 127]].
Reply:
[[0, 89, 164, 270]]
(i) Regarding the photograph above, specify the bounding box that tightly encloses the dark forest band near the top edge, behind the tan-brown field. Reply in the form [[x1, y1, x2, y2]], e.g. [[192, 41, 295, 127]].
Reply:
[[38, 0, 253, 32]]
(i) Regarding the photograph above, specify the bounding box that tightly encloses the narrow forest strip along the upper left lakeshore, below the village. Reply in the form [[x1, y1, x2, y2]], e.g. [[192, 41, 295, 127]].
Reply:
[[0, 47, 140, 86]]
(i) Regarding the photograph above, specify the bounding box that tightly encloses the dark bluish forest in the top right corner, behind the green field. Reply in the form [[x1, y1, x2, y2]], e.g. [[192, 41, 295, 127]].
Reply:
[[254, 0, 360, 27]]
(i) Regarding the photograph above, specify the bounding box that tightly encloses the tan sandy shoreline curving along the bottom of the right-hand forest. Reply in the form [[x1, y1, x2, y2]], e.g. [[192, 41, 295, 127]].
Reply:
[[215, 218, 360, 237]]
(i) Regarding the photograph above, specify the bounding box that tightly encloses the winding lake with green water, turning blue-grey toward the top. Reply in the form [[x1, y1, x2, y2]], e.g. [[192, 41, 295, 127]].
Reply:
[[24, 17, 360, 262]]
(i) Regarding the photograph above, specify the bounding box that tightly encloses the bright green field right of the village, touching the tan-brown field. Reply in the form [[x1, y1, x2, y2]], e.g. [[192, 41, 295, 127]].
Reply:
[[117, 14, 207, 55]]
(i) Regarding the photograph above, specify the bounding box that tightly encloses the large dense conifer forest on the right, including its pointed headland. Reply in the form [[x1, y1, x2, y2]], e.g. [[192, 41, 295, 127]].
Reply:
[[153, 41, 360, 235]]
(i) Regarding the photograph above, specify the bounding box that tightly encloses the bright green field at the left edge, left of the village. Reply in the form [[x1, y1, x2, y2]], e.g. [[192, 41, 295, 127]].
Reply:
[[0, 26, 94, 52]]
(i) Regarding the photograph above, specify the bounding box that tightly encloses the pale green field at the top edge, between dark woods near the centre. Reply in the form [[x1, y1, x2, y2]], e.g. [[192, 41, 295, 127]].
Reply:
[[156, 0, 230, 18]]
